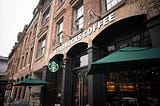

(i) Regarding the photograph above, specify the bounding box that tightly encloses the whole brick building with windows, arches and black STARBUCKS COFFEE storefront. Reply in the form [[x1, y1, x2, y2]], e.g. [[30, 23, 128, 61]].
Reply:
[[5, 0, 160, 106]]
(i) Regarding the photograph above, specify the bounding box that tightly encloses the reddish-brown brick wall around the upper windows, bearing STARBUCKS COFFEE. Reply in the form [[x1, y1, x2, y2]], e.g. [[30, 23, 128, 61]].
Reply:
[[7, 0, 160, 106]]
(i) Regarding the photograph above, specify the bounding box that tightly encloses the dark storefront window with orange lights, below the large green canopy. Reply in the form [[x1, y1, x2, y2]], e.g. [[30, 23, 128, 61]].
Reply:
[[105, 68, 160, 106]]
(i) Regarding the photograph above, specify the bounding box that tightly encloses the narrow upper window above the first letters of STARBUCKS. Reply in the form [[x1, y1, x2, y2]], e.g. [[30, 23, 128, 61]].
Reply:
[[57, 20, 63, 43]]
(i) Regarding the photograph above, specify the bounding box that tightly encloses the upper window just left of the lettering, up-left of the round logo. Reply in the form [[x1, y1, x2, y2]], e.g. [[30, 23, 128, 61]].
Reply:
[[37, 36, 46, 57]]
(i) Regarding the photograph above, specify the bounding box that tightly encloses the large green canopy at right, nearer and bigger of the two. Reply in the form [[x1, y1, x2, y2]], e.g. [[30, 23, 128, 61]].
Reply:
[[88, 47, 160, 75]]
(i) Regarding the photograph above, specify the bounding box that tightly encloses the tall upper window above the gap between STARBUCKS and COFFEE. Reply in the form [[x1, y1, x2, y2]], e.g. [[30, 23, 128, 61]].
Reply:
[[73, 5, 84, 31]]
